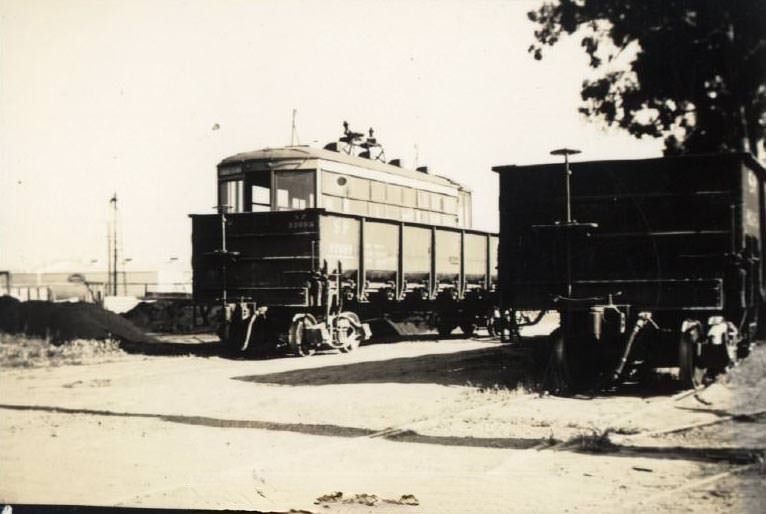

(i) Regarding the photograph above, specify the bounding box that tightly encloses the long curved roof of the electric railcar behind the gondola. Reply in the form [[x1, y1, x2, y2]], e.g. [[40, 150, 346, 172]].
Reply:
[[219, 146, 469, 191]]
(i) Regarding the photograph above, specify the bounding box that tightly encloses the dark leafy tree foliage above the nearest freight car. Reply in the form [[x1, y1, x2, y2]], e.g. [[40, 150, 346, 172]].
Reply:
[[528, 0, 766, 154]]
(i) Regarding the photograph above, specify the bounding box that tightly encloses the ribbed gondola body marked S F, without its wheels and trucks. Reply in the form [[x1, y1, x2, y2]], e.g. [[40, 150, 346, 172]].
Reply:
[[192, 209, 497, 307]]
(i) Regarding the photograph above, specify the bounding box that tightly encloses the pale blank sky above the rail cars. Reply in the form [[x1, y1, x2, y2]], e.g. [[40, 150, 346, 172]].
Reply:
[[0, 0, 662, 271]]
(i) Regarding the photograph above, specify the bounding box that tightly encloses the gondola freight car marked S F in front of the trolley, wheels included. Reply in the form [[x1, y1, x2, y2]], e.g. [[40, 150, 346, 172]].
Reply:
[[192, 209, 497, 355]]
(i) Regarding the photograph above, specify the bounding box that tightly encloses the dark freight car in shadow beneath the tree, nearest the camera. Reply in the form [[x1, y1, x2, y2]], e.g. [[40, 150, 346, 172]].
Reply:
[[493, 149, 766, 391]]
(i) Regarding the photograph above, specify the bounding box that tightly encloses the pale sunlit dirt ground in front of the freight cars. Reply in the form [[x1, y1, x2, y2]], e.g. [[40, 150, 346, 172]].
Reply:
[[0, 320, 766, 514]]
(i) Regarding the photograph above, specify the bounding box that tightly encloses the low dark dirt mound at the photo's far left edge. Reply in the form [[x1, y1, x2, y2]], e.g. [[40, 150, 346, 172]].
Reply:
[[0, 296, 154, 343]]
